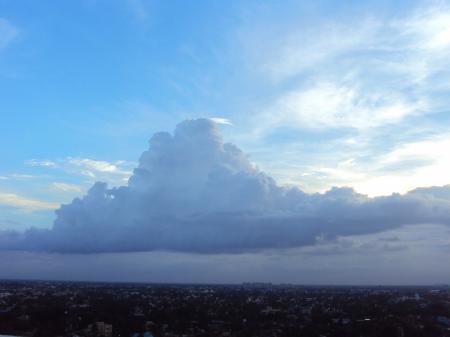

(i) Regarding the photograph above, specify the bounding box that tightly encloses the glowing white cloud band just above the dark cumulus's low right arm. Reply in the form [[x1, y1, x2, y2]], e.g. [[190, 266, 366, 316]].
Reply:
[[286, 133, 450, 197]]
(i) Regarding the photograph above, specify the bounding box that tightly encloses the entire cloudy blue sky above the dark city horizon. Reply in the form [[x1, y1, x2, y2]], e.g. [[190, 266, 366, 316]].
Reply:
[[0, 0, 450, 284]]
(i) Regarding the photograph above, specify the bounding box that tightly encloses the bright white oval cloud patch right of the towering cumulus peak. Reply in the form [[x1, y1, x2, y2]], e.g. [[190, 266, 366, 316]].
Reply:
[[265, 82, 425, 129]]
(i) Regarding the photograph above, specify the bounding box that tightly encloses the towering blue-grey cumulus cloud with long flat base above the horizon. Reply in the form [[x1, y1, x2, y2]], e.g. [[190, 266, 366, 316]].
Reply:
[[0, 119, 450, 253]]
